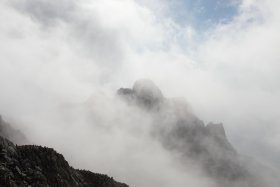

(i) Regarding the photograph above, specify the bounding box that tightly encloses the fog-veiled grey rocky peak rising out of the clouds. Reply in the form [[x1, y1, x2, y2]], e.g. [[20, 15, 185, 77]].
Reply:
[[118, 81, 252, 185]]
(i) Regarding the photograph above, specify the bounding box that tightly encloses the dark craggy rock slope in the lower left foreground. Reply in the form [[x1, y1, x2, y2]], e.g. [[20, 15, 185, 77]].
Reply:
[[0, 136, 128, 187]]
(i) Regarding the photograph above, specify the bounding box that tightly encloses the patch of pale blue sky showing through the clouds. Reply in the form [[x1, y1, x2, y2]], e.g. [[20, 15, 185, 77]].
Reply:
[[172, 0, 238, 29]]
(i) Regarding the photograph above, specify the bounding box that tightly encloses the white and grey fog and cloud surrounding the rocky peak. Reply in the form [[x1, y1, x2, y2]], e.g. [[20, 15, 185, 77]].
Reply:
[[0, 0, 280, 187]]
